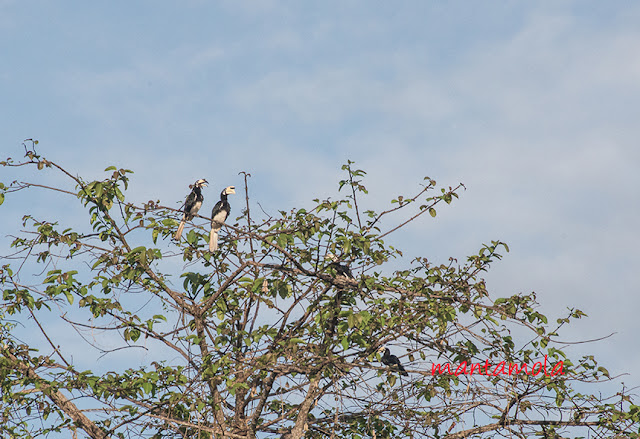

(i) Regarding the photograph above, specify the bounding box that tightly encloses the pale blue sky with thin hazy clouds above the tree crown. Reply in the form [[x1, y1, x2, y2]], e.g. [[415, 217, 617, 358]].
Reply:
[[0, 0, 640, 392]]
